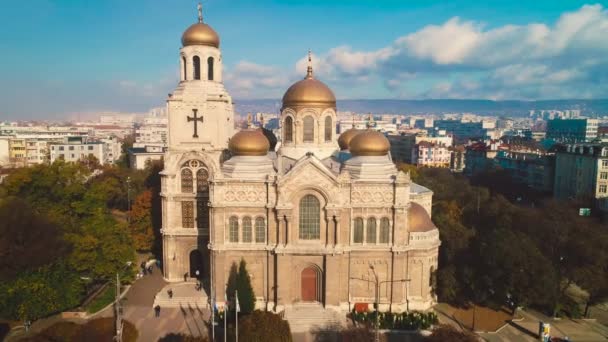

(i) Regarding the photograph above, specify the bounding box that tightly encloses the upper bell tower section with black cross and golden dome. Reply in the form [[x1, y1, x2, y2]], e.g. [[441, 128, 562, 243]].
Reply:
[[167, 4, 234, 151]]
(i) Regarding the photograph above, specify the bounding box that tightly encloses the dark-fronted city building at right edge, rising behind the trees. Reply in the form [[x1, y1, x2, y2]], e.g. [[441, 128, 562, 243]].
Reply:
[[553, 143, 608, 199]]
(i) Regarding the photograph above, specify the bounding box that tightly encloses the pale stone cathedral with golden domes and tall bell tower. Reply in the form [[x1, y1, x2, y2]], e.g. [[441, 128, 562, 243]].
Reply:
[[161, 7, 440, 311]]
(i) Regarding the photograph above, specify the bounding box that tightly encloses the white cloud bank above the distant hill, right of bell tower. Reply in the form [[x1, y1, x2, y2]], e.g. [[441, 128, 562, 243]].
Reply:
[[227, 4, 608, 99]]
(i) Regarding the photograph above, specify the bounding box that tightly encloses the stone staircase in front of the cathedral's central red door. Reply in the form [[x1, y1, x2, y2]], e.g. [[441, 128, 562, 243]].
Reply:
[[284, 303, 346, 332]]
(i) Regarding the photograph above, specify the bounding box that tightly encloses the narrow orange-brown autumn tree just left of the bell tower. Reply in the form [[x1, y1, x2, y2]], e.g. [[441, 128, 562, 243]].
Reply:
[[129, 190, 154, 252]]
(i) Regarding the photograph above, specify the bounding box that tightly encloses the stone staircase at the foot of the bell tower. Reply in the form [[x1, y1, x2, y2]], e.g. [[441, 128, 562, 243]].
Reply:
[[152, 282, 209, 310]]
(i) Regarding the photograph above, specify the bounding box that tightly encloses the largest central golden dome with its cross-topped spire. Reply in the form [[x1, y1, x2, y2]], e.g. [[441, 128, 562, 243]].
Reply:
[[283, 51, 336, 108]]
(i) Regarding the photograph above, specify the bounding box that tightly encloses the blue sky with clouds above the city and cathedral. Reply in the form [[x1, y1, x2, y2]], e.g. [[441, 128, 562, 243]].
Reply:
[[0, 0, 608, 119]]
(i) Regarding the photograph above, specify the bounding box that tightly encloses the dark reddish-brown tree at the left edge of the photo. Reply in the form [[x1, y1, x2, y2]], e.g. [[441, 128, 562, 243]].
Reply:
[[0, 197, 69, 280]]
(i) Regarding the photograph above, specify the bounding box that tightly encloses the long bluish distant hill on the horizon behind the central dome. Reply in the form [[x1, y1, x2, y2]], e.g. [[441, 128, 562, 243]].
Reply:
[[235, 99, 608, 116]]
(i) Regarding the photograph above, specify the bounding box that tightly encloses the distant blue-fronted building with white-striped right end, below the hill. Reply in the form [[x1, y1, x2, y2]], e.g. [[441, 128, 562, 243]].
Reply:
[[546, 119, 598, 143]]
